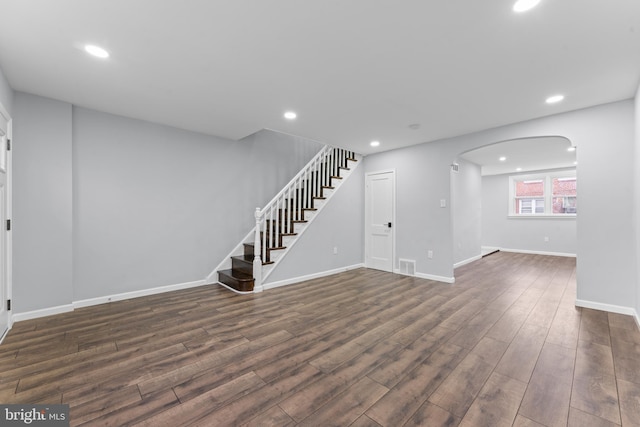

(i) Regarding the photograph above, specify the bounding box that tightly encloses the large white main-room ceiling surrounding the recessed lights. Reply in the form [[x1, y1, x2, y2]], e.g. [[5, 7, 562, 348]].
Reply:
[[0, 0, 640, 154]]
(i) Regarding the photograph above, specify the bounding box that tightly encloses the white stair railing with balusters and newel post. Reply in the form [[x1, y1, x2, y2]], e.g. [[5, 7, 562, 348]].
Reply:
[[253, 145, 354, 289]]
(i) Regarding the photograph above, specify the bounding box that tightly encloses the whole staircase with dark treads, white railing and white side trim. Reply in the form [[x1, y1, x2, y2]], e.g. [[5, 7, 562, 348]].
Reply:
[[217, 146, 358, 293]]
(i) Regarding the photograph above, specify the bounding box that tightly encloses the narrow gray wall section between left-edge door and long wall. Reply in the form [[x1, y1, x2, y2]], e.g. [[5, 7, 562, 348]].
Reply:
[[13, 92, 73, 313]]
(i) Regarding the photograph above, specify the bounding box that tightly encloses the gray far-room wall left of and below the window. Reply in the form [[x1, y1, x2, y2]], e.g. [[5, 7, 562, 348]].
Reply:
[[482, 171, 582, 255]]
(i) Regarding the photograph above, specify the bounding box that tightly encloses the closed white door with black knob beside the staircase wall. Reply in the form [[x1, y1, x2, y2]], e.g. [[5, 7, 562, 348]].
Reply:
[[365, 171, 396, 272]]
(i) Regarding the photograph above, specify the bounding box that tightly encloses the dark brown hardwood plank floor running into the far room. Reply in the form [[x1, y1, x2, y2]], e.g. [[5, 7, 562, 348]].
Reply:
[[0, 253, 640, 427]]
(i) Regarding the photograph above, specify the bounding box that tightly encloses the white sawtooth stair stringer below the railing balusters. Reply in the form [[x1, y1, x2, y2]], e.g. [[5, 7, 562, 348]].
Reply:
[[258, 154, 362, 292]]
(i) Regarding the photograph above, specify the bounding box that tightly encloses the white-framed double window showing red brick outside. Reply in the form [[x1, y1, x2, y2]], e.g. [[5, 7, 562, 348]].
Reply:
[[509, 170, 578, 217]]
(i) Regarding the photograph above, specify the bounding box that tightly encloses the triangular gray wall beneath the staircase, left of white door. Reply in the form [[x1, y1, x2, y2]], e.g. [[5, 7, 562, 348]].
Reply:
[[266, 162, 364, 284]]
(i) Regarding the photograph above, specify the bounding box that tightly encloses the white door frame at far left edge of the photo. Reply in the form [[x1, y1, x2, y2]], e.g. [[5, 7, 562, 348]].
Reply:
[[0, 103, 14, 344]]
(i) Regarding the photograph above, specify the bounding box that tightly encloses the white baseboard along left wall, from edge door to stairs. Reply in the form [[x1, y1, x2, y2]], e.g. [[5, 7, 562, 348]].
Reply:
[[12, 280, 207, 322]]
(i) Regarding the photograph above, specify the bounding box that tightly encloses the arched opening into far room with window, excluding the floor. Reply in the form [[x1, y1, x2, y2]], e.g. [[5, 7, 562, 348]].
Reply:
[[451, 136, 577, 267]]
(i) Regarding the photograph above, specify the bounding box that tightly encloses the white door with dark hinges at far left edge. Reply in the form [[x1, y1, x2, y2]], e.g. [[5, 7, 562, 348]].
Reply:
[[0, 105, 11, 340]]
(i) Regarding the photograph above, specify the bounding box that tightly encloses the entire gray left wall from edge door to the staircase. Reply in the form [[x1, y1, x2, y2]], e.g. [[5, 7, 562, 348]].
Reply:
[[13, 93, 321, 313]]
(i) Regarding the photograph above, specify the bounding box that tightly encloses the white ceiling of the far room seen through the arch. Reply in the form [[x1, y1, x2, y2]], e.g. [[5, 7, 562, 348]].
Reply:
[[460, 136, 577, 176]]
